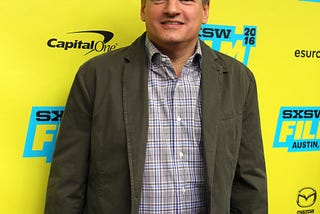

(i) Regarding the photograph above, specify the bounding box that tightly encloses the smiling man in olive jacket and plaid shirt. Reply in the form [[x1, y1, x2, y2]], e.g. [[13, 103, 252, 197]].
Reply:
[[46, 0, 268, 214]]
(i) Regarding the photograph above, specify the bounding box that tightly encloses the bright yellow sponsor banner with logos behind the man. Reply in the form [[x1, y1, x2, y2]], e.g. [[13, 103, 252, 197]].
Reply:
[[0, 0, 320, 214]]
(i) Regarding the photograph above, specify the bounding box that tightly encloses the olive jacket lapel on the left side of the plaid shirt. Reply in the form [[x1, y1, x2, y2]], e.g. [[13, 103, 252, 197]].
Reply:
[[122, 33, 148, 213]]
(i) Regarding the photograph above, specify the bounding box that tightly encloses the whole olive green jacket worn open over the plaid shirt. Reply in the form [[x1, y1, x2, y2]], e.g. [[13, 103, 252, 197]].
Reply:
[[45, 34, 268, 214]]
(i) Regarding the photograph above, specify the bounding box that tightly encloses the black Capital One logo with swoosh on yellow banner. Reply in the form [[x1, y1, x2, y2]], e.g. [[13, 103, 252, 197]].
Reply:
[[47, 30, 117, 55]]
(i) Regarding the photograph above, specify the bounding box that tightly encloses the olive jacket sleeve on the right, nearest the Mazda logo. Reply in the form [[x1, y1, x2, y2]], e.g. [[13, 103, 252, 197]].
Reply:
[[230, 71, 268, 214]]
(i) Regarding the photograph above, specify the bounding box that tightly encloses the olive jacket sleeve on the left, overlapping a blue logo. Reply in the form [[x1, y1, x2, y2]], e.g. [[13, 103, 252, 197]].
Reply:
[[45, 65, 93, 214]]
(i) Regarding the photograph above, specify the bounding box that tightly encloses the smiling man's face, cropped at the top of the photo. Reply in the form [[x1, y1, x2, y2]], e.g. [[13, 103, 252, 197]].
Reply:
[[141, 0, 209, 47]]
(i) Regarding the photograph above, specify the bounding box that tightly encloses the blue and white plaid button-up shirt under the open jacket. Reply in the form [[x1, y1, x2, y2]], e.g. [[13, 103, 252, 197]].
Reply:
[[140, 39, 207, 214]]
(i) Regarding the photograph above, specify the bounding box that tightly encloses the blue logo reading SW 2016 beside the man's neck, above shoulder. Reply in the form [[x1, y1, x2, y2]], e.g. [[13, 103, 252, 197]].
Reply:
[[199, 24, 257, 65]]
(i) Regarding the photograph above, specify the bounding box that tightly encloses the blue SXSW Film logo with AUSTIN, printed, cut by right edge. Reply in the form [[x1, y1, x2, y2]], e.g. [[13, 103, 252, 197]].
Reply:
[[273, 107, 320, 152]]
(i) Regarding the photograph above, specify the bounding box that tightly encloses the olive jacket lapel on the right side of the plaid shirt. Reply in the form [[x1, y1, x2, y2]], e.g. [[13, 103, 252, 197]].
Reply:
[[201, 42, 224, 201]]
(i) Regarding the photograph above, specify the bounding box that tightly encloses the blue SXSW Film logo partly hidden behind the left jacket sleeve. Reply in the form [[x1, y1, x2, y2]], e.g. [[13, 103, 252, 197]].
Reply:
[[23, 106, 64, 163]]
